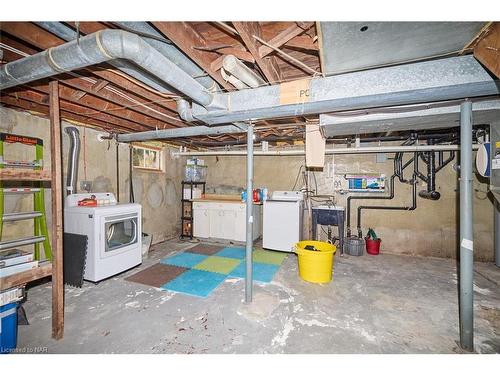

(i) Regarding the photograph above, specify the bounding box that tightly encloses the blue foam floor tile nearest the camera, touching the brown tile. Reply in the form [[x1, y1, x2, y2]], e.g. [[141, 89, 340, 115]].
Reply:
[[161, 270, 226, 297]]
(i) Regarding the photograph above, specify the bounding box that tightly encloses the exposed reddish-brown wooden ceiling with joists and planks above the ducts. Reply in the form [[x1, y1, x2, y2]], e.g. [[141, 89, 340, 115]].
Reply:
[[0, 22, 320, 147]]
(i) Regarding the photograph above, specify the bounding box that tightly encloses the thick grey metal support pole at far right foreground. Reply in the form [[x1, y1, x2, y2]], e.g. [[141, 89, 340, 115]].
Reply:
[[460, 100, 474, 351]]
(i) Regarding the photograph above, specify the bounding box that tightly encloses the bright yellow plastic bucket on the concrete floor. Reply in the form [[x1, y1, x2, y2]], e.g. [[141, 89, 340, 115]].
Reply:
[[295, 241, 337, 283]]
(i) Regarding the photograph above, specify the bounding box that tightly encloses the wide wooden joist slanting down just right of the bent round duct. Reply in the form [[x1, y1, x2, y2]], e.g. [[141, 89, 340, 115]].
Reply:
[[153, 22, 233, 90]]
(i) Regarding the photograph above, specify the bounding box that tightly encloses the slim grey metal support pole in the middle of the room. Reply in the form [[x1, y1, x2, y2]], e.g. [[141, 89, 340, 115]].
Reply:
[[245, 124, 254, 302]]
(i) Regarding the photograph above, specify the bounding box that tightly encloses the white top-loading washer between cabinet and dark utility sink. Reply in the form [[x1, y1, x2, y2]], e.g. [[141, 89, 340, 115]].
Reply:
[[262, 191, 304, 252]]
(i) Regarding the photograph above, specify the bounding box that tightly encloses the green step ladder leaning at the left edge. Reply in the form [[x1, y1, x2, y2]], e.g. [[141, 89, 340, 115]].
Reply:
[[0, 133, 52, 260]]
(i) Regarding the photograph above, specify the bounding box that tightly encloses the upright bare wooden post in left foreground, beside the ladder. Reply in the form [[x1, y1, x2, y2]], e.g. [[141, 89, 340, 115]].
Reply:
[[49, 81, 64, 340]]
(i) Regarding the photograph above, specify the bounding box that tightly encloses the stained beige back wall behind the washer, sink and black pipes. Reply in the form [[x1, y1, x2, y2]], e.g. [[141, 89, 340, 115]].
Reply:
[[203, 148, 494, 261]]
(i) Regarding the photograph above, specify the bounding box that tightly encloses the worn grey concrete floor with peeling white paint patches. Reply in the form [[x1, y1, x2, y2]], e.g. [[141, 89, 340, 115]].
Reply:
[[18, 241, 500, 353]]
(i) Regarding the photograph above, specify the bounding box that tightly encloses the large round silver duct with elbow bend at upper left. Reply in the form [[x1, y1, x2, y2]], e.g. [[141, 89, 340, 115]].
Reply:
[[0, 29, 214, 106]]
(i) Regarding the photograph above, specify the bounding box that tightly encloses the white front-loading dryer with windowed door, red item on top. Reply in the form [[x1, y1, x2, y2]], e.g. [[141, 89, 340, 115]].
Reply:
[[64, 193, 142, 282]]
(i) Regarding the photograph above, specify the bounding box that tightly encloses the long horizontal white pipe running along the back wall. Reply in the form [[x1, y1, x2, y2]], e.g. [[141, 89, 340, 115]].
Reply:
[[172, 145, 479, 157]]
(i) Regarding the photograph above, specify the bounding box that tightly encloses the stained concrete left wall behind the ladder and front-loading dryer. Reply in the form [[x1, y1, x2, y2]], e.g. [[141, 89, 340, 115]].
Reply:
[[0, 107, 184, 253]]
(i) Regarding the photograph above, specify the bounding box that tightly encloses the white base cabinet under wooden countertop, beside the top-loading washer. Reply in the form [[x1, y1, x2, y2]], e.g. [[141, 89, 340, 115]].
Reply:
[[193, 202, 262, 242]]
